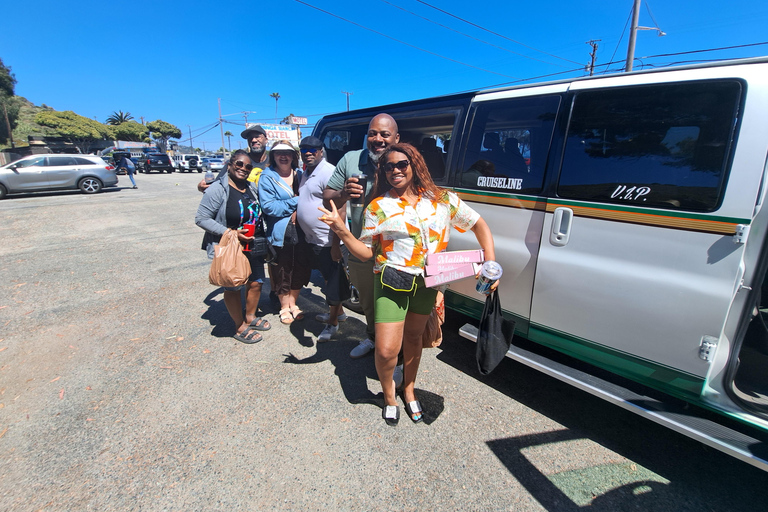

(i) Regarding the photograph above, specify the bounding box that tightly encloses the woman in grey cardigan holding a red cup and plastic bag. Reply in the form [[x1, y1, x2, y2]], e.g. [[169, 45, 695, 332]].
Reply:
[[195, 149, 271, 343]]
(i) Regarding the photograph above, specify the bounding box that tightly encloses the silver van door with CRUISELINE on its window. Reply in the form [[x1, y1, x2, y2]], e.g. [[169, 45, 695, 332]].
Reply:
[[446, 93, 565, 333]]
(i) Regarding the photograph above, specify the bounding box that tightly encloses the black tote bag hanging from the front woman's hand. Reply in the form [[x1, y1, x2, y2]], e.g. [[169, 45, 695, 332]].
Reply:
[[476, 291, 515, 375]]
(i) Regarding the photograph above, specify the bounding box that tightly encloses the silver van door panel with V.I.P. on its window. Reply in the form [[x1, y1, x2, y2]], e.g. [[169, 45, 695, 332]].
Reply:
[[530, 80, 749, 396]]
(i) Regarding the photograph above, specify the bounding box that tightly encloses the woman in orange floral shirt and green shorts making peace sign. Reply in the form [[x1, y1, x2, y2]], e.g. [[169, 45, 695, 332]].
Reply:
[[320, 144, 498, 425]]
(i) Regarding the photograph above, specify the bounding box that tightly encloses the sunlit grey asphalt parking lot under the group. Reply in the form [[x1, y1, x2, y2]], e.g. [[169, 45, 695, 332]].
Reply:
[[0, 173, 768, 511]]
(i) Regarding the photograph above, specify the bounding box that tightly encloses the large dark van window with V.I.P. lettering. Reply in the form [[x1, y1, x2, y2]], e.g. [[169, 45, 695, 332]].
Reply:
[[557, 81, 741, 211]]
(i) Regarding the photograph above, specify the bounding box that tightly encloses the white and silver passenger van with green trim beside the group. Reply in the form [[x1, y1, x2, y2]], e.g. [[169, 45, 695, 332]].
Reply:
[[314, 58, 768, 469]]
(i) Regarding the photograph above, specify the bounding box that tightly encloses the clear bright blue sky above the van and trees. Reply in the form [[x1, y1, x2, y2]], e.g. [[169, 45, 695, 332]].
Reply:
[[0, 0, 768, 149]]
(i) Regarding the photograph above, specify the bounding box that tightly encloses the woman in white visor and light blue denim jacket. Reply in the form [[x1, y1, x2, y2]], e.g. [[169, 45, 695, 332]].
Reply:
[[259, 141, 312, 324]]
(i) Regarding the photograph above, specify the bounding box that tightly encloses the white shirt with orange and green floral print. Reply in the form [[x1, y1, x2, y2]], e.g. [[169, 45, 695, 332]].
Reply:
[[360, 190, 480, 275]]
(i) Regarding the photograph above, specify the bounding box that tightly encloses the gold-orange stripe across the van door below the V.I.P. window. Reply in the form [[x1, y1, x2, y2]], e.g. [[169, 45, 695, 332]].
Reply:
[[546, 202, 748, 235]]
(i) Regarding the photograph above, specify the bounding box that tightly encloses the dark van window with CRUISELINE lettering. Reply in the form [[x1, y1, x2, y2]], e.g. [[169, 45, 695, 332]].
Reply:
[[456, 96, 560, 194]]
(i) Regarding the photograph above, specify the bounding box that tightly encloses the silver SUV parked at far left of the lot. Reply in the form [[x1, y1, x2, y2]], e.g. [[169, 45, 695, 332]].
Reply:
[[0, 155, 117, 199]]
